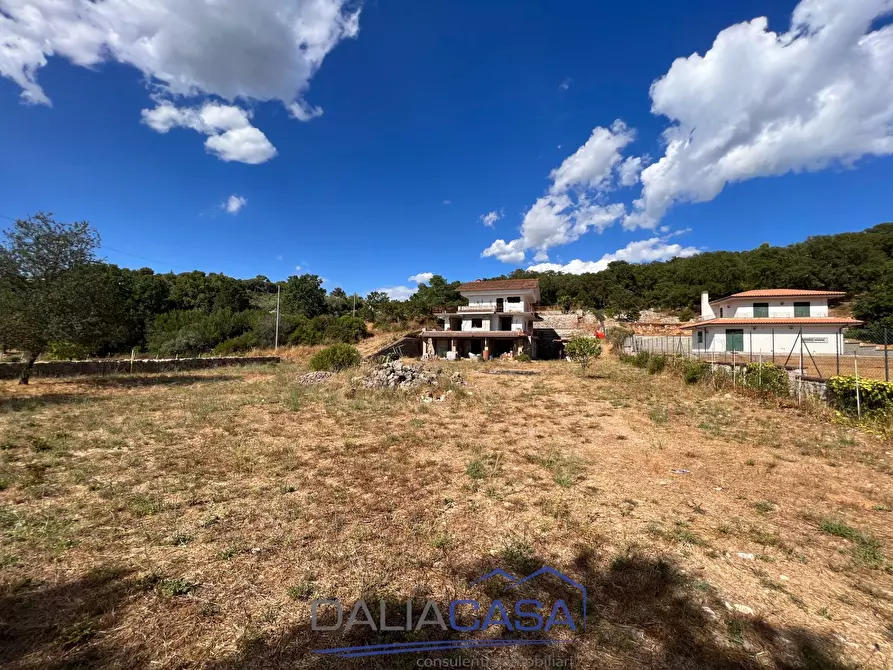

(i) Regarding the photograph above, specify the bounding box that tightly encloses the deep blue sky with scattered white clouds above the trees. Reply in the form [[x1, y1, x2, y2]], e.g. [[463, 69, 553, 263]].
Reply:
[[0, 0, 893, 295]]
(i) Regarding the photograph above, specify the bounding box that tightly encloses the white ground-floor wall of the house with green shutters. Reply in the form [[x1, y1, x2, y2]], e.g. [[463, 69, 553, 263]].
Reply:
[[692, 326, 843, 356]]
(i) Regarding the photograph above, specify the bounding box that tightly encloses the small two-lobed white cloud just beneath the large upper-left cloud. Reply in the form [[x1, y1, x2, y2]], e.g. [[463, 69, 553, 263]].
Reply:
[[140, 102, 277, 165]]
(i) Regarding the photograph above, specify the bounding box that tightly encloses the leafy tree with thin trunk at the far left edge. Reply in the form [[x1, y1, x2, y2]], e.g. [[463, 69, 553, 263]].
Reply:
[[0, 212, 124, 384]]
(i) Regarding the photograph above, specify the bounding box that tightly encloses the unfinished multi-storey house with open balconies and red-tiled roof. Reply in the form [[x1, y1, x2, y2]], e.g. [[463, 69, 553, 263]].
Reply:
[[421, 279, 540, 358]]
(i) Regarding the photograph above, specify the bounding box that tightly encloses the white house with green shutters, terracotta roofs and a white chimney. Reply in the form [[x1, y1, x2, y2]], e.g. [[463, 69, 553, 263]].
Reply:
[[682, 289, 862, 355]]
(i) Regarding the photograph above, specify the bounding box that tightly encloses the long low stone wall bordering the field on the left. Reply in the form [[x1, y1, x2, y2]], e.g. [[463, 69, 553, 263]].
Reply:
[[0, 356, 279, 379]]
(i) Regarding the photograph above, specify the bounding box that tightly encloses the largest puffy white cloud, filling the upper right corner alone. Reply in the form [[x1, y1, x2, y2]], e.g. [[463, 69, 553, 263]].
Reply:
[[624, 0, 893, 228]]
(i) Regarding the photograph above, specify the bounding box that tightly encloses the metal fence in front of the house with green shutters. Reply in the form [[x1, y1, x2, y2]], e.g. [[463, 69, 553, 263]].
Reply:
[[623, 326, 893, 381]]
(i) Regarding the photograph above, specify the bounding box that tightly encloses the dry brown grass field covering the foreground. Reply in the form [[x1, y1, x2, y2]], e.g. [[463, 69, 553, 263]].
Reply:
[[0, 356, 893, 669]]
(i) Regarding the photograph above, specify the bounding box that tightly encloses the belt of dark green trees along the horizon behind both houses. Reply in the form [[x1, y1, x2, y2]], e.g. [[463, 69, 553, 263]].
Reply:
[[0, 213, 893, 379]]
